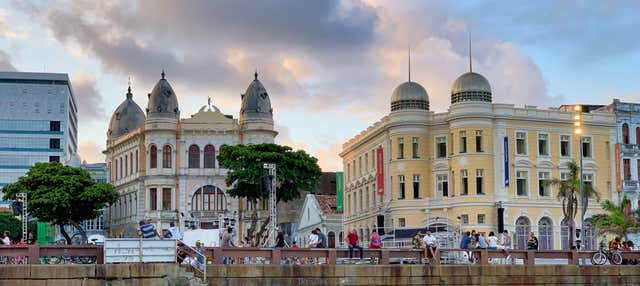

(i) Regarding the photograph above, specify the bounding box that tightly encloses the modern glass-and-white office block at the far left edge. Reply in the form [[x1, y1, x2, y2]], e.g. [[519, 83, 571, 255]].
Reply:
[[0, 72, 78, 199]]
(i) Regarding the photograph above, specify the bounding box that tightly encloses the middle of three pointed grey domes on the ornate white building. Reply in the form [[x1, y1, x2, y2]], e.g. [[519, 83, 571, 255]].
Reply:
[[147, 71, 180, 118]]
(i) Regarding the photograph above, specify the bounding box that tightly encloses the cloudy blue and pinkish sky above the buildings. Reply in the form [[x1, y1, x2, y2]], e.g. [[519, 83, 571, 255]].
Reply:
[[0, 0, 640, 171]]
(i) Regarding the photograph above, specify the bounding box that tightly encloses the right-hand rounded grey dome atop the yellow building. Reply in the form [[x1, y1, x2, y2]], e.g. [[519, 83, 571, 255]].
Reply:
[[451, 72, 491, 104]]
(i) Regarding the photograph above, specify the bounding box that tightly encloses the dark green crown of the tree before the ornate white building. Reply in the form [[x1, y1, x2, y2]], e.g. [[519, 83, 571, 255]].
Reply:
[[218, 144, 322, 202]]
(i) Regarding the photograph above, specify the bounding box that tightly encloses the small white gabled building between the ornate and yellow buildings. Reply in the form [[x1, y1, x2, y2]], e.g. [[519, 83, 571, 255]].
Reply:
[[293, 194, 344, 248]]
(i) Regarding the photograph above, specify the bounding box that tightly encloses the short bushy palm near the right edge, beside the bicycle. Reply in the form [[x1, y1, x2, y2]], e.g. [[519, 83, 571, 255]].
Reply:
[[589, 196, 640, 240]]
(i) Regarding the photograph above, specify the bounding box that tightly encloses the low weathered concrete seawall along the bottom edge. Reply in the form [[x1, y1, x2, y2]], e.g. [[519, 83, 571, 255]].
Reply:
[[0, 264, 640, 286]]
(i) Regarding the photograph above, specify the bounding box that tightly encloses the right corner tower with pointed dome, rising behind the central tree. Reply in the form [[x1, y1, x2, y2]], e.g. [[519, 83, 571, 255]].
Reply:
[[239, 71, 278, 144]]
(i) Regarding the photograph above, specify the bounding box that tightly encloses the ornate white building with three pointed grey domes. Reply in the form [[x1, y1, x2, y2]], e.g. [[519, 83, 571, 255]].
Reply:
[[104, 72, 278, 237]]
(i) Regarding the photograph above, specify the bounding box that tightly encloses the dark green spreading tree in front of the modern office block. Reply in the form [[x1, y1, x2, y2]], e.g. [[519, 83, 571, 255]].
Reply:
[[2, 162, 119, 244]]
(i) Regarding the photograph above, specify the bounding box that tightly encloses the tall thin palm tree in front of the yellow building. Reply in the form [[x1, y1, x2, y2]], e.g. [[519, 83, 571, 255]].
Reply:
[[550, 161, 600, 248]]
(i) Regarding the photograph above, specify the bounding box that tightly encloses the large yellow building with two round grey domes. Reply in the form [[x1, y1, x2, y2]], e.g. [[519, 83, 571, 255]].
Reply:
[[340, 68, 616, 249]]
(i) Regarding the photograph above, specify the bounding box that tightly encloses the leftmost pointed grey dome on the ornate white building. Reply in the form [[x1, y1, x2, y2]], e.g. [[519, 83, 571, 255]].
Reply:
[[107, 87, 144, 138]]
